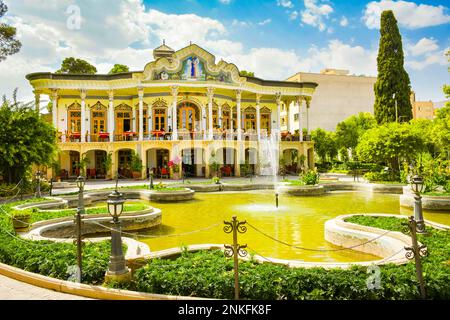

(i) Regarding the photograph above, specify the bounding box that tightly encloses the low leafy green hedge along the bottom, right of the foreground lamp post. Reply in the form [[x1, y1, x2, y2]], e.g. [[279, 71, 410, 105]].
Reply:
[[126, 216, 450, 300]]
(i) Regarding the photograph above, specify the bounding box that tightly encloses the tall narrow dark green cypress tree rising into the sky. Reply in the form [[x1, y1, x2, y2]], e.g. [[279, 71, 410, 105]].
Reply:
[[374, 10, 413, 124]]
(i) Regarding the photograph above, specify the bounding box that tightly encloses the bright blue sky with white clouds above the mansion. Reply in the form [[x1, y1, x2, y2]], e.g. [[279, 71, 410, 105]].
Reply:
[[0, 0, 450, 101]]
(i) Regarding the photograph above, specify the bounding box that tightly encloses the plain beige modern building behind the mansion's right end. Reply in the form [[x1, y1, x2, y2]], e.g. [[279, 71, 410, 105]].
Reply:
[[281, 69, 377, 132]]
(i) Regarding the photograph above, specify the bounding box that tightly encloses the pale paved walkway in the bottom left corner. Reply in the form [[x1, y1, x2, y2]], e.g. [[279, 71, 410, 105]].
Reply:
[[0, 275, 91, 300]]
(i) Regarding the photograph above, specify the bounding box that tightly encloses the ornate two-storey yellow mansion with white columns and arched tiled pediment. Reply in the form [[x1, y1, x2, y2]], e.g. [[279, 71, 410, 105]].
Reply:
[[27, 44, 317, 178]]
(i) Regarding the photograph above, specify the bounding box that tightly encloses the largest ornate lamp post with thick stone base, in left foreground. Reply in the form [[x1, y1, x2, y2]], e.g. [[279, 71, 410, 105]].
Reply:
[[105, 188, 131, 282]]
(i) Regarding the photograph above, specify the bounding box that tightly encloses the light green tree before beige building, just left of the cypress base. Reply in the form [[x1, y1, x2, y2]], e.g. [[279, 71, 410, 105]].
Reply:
[[336, 112, 377, 155]]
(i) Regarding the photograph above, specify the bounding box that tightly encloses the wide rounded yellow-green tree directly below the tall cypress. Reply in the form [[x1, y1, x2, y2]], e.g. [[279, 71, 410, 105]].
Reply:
[[356, 122, 425, 176]]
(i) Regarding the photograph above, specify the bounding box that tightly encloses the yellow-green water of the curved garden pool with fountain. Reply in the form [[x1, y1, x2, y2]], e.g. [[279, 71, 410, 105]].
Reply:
[[140, 191, 450, 262]]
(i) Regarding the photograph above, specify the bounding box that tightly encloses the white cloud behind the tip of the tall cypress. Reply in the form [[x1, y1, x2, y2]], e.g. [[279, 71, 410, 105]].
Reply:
[[363, 0, 450, 29]]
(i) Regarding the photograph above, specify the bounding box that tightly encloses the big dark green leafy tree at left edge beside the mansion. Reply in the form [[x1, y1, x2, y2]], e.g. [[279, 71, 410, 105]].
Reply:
[[0, 90, 56, 183]]
